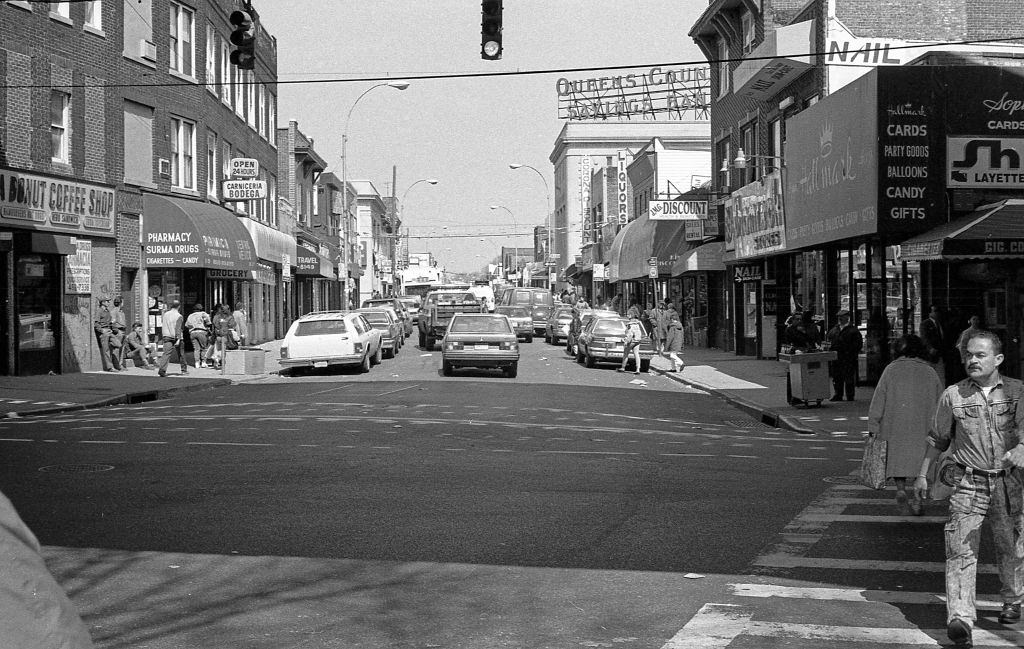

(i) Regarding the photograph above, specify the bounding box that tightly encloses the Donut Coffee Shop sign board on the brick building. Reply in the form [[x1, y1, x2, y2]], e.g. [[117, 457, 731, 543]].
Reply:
[[0, 168, 117, 237]]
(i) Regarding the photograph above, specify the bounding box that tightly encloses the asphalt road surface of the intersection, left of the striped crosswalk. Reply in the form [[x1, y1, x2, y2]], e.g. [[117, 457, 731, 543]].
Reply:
[[0, 339, 937, 649]]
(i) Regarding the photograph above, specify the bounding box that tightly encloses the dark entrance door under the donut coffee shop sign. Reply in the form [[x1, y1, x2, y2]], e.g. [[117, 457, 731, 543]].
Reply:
[[14, 255, 60, 376]]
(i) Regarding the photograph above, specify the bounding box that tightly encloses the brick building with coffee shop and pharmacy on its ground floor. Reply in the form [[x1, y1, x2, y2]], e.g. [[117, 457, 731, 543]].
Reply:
[[0, 0, 294, 374]]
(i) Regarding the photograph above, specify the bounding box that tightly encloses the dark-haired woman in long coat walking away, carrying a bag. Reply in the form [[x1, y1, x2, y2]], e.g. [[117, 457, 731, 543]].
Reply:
[[867, 334, 943, 515]]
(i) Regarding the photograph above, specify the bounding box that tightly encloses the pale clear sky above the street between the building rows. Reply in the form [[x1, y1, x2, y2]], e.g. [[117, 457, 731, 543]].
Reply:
[[253, 0, 708, 272]]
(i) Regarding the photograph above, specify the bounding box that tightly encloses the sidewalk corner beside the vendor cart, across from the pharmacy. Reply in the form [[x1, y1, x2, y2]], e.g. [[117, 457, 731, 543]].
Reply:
[[650, 347, 874, 434]]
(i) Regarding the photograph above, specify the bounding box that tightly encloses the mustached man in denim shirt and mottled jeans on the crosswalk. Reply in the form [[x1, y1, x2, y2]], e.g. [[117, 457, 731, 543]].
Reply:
[[913, 331, 1024, 647]]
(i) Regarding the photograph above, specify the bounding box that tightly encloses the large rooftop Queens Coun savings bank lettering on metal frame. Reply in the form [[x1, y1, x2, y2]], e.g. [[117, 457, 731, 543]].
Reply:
[[555, 66, 711, 122]]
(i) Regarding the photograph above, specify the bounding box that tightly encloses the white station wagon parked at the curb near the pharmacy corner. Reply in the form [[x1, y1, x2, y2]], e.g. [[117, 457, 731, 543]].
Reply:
[[280, 311, 383, 376]]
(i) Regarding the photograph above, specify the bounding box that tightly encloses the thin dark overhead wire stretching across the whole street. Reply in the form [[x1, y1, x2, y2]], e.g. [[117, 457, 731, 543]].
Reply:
[[0, 35, 1024, 89]]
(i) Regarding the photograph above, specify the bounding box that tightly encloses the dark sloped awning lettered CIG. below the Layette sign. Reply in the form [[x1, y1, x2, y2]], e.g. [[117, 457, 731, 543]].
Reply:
[[899, 199, 1024, 261]]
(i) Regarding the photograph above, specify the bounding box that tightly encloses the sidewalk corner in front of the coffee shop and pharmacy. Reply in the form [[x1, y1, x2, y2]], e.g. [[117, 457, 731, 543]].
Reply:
[[0, 341, 281, 418]]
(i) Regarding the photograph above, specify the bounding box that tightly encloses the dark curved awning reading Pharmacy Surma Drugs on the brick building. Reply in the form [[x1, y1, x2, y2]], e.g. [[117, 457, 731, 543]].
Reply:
[[142, 193, 256, 273]]
